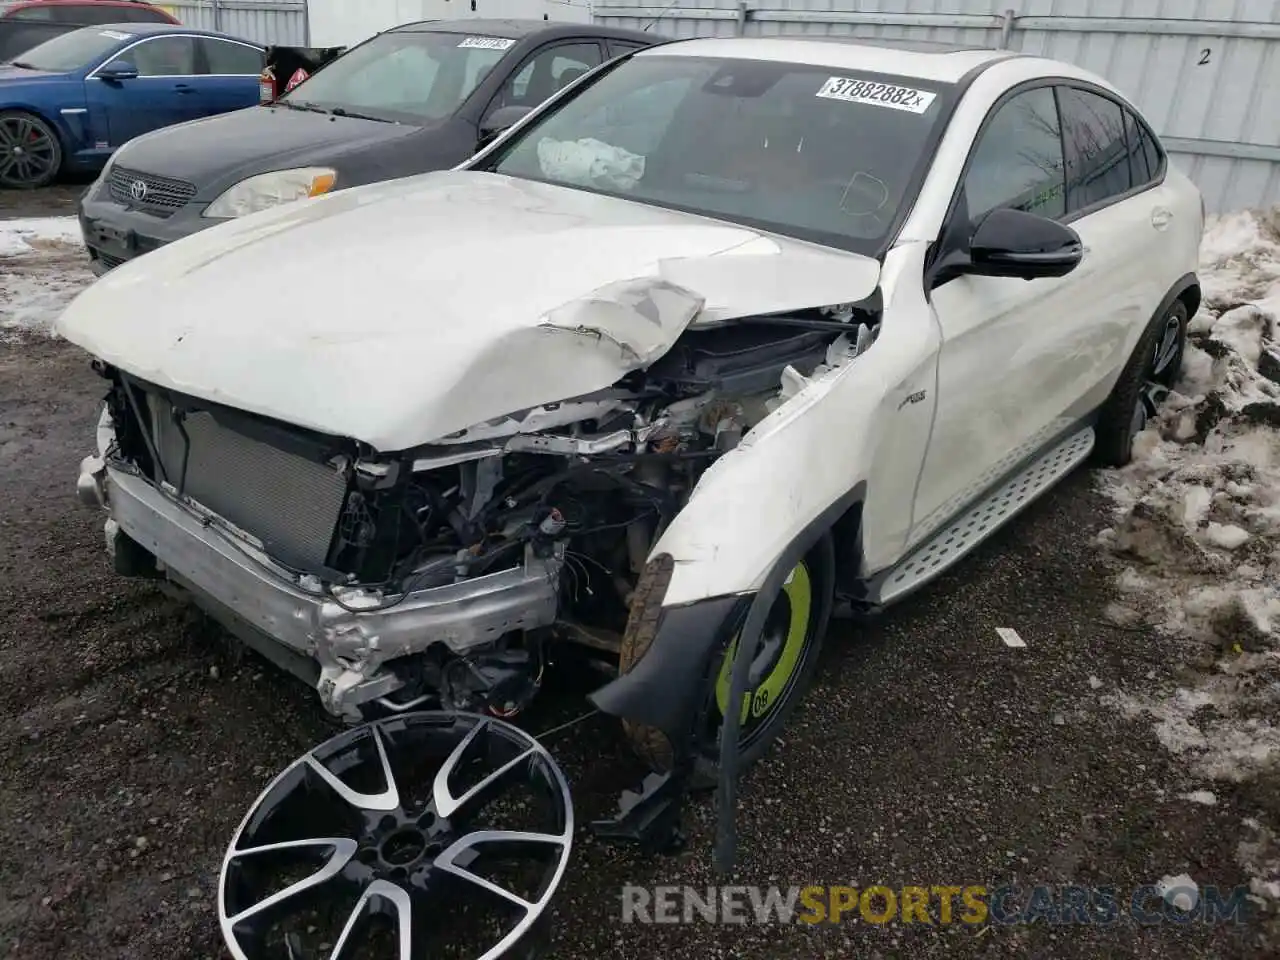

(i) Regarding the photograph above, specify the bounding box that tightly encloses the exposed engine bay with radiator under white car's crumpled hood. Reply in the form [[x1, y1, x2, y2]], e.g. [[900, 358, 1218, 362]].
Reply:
[[99, 302, 879, 718]]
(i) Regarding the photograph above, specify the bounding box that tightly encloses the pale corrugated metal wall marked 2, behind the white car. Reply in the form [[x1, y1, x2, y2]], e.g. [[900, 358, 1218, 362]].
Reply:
[[594, 0, 1280, 211]]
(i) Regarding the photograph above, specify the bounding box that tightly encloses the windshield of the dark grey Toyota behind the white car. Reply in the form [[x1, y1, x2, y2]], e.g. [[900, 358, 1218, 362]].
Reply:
[[282, 32, 516, 123]]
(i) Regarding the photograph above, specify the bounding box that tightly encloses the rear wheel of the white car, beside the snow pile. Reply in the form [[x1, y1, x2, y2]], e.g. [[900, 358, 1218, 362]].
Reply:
[[1093, 300, 1188, 467]]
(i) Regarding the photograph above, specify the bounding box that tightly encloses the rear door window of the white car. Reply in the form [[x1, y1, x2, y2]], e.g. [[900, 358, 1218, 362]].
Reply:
[[1059, 87, 1131, 212]]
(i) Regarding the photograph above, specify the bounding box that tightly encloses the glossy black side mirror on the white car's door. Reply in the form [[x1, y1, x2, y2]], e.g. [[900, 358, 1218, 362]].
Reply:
[[963, 209, 1084, 280]]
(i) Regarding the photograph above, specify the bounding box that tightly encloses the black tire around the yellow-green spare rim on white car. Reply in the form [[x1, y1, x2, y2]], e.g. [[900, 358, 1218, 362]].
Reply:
[[618, 538, 835, 788]]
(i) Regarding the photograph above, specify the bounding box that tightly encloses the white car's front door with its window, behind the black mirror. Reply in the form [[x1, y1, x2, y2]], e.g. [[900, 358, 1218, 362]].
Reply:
[[908, 84, 1114, 547]]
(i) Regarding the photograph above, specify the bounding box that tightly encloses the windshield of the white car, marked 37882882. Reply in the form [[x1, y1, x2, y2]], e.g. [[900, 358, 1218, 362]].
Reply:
[[486, 55, 950, 252]]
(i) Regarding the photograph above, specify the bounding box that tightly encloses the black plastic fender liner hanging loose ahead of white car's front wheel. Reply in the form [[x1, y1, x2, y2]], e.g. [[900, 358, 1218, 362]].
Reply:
[[588, 578, 754, 750]]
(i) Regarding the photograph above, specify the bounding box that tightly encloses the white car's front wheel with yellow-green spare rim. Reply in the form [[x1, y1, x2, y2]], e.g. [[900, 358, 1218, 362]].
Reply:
[[620, 552, 832, 786]]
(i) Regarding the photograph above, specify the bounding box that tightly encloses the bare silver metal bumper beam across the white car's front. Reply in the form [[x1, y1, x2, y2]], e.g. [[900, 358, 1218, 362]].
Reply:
[[77, 457, 562, 719]]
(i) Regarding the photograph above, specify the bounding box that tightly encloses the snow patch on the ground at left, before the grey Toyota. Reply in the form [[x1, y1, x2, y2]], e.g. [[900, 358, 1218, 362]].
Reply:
[[0, 216, 93, 342]]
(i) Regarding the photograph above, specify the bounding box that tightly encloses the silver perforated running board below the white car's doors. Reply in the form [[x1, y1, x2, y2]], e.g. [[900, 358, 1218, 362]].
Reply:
[[867, 426, 1094, 607]]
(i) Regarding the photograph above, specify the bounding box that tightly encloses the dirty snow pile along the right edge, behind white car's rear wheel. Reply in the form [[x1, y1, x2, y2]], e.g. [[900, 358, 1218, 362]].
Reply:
[[1100, 207, 1280, 896]]
